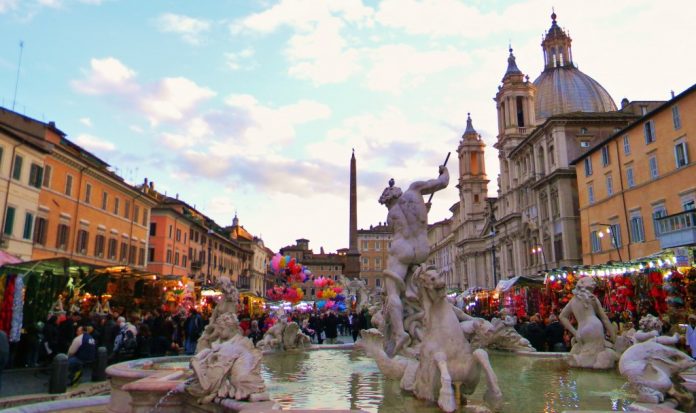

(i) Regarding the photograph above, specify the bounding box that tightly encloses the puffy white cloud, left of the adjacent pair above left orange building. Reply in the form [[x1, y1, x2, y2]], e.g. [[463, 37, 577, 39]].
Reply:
[[72, 57, 138, 95]]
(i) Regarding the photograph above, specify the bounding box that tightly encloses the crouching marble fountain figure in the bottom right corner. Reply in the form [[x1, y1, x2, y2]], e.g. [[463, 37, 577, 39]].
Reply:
[[619, 315, 696, 411]]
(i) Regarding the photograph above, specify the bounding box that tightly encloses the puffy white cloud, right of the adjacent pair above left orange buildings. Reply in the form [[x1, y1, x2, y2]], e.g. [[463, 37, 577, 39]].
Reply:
[[140, 77, 216, 125]]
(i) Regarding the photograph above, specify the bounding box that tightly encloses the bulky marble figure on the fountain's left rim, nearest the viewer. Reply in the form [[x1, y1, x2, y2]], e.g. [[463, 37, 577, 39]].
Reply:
[[185, 313, 269, 404]]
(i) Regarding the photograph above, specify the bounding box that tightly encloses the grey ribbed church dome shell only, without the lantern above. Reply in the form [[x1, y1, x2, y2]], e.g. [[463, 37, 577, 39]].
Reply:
[[534, 66, 617, 119]]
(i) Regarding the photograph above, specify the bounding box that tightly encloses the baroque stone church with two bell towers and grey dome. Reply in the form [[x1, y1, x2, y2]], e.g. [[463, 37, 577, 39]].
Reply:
[[450, 13, 657, 290]]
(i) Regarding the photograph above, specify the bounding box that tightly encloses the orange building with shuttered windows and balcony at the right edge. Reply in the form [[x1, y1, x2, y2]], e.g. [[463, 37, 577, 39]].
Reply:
[[572, 85, 696, 264]]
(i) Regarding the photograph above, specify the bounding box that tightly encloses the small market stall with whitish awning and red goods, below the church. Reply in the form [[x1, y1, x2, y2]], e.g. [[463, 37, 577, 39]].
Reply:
[[495, 276, 549, 319]]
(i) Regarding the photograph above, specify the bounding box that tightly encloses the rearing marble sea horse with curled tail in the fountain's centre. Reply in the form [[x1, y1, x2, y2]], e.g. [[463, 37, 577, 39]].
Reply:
[[357, 264, 502, 412]]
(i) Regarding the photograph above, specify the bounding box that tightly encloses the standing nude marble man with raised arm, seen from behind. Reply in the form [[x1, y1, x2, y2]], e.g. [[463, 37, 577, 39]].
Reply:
[[379, 165, 449, 356]]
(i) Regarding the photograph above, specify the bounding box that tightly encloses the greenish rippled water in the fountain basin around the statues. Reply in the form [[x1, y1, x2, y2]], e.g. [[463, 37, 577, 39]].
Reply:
[[262, 350, 632, 413]]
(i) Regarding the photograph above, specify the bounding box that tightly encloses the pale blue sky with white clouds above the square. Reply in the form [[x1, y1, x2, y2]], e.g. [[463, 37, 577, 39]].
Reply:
[[0, 0, 696, 252]]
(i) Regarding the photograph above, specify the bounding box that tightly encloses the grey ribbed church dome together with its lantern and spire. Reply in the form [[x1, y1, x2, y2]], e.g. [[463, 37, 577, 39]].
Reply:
[[534, 13, 617, 120]]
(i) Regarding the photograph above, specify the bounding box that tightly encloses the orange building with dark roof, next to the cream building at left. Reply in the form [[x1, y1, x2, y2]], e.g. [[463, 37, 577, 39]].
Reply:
[[2, 111, 155, 269]]
